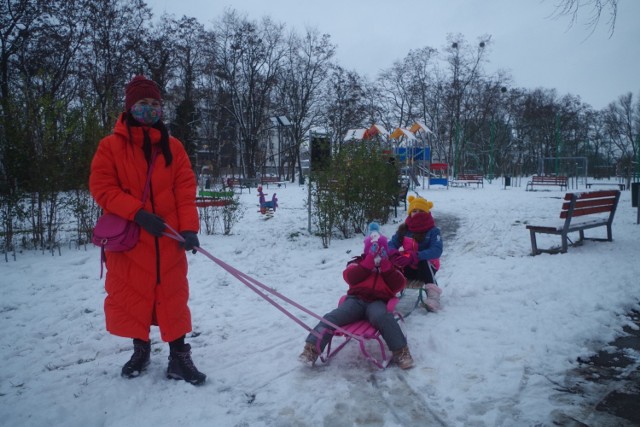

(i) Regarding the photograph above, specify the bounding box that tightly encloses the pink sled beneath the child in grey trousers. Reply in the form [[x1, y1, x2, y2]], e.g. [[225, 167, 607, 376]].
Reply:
[[318, 295, 404, 369]]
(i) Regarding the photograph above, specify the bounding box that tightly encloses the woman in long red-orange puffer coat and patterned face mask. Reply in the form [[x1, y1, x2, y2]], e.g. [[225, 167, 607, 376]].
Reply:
[[89, 75, 206, 385]]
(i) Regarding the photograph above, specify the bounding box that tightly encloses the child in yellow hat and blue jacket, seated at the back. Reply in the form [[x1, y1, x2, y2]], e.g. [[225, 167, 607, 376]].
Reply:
[[389, 195, 442, 312]]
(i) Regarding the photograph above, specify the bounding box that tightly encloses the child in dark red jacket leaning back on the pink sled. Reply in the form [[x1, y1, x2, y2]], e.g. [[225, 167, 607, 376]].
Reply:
[[299, 223, 413, 369]]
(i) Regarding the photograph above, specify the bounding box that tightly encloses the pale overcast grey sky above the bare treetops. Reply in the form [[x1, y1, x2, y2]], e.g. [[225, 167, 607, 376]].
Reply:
[[147, 0, 640, 109]]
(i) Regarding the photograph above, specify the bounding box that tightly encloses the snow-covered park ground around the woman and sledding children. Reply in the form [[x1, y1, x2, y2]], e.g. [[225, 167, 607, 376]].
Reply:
[[0, 179, 640, 427]]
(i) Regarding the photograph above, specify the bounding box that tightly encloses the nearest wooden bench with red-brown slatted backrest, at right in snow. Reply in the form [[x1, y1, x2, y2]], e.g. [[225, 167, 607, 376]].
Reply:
[[527, 190, 620, 256]]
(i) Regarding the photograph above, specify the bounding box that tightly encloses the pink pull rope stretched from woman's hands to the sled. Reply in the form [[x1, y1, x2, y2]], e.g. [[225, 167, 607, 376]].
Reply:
[[162, 223, 363, 344]]
